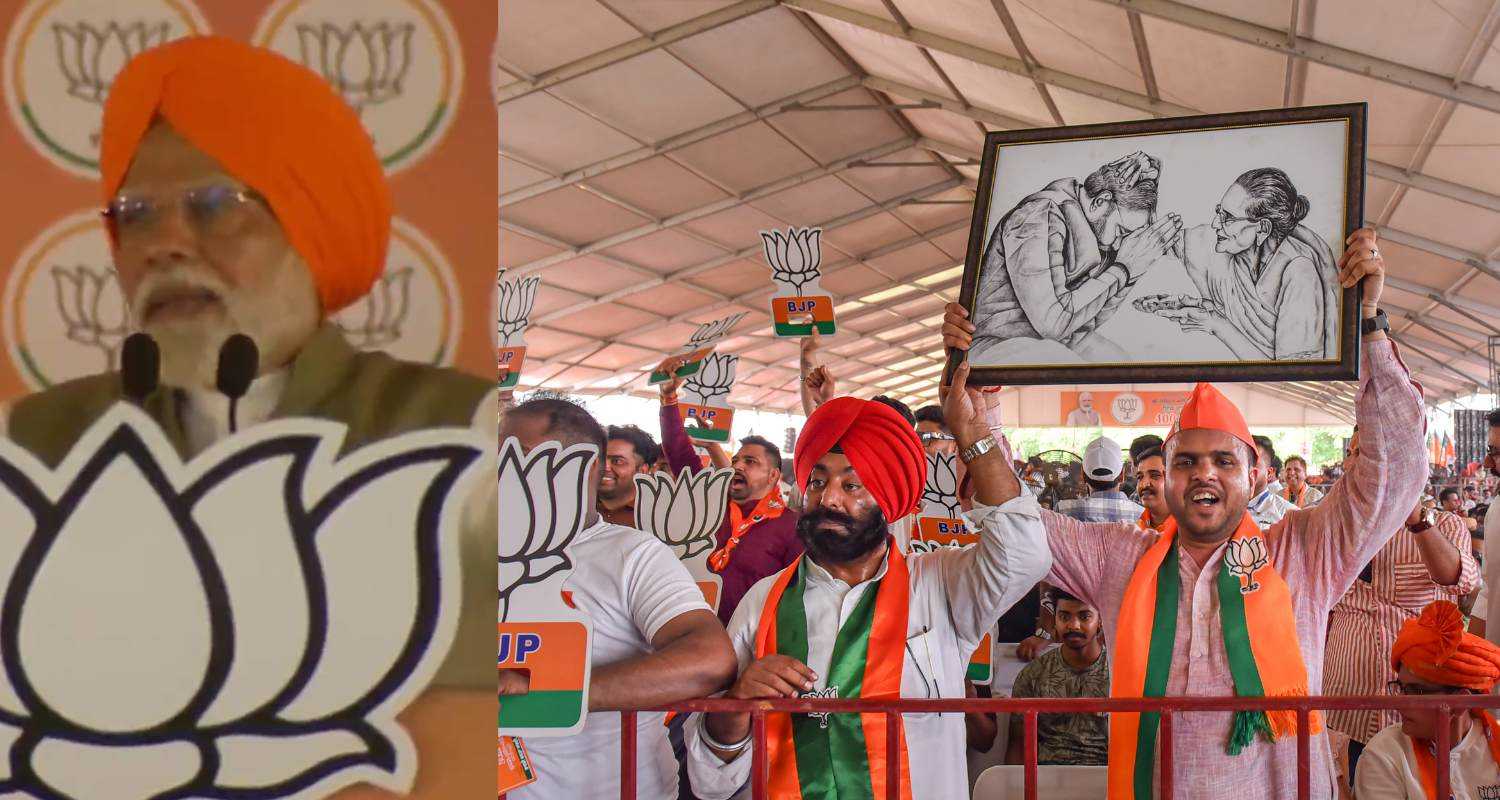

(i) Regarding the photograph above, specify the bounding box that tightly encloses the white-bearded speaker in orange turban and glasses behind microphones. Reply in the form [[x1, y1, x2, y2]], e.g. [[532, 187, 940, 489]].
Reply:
[[6, 36, 498, 797]]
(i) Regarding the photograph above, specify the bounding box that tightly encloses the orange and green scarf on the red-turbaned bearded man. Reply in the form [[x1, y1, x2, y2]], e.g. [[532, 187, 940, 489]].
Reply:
[[755, 540, 912, 800]]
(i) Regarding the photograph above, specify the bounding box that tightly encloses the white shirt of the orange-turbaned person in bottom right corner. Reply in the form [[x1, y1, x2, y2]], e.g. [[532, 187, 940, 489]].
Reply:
[[1355, 720, 1500, 800]]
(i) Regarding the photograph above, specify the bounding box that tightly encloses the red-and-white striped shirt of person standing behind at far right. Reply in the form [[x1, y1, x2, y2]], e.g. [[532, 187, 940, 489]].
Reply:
[[1323, 513, 1479, 743]]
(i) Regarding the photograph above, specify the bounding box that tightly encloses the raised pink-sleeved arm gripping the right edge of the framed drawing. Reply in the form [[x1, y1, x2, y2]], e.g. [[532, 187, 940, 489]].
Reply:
[[1289, 228, 1428, 605]]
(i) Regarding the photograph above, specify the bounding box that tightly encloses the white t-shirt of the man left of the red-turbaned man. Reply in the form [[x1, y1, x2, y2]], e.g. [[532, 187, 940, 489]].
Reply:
[[510, 519, 711, 800]]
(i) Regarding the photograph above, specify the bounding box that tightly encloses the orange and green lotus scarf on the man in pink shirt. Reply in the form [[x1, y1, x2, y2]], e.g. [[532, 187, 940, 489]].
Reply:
[[1109, 513, 1323, 800]]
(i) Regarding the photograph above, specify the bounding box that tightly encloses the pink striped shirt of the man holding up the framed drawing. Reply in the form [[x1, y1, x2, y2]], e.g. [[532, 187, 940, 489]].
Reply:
[[1043, 341, 1428, 800]]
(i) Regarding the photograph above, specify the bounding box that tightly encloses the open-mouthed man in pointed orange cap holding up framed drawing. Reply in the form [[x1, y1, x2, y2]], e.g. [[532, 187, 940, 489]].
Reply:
[[944, 230, 1427, 800]]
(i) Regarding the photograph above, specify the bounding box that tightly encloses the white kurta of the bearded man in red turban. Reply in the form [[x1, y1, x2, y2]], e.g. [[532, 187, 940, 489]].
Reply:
[[684, 495, 1052, 800]]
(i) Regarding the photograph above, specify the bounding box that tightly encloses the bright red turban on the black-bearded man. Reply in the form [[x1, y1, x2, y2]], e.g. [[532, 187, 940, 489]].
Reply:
[[797, 398, 927, 522]]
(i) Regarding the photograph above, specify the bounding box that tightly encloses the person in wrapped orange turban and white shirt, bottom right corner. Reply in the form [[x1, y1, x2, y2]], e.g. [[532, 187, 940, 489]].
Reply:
[[1355, 600, 1500, 800]]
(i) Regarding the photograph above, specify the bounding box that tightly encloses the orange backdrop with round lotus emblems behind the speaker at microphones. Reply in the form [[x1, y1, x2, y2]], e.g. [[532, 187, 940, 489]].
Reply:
[[0, 0, 498, 402]]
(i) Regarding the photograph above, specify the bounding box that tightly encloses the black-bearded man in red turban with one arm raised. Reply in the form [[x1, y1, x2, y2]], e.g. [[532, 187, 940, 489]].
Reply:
[[684, 372, 1049, 800]]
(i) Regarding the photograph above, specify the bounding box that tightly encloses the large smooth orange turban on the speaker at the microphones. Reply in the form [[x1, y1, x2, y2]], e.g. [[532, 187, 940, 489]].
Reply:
[[99, 36, 392, 314]]
